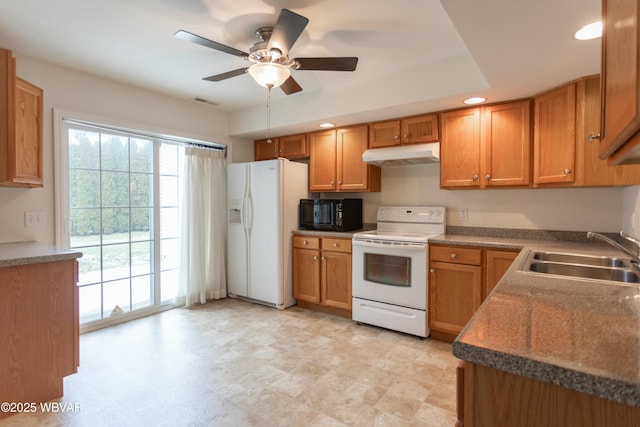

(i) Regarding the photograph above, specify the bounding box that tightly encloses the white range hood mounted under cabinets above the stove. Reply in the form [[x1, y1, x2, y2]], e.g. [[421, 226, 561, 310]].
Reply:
[[362, 142, 440, 166]]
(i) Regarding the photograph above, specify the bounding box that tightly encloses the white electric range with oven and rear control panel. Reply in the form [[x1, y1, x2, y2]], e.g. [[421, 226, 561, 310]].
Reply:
[[352, 206, 446, 338]]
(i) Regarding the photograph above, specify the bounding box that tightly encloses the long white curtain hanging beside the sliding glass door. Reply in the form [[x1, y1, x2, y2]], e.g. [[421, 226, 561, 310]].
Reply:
[[180, 147, 227, 307]]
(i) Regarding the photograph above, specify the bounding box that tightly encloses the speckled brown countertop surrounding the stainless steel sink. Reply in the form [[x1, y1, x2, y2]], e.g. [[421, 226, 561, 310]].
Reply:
[[440, 229, 640, 407]]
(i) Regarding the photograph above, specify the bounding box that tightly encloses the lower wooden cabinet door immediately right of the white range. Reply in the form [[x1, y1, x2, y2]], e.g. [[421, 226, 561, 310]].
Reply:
[[429, 262, 482, 334]]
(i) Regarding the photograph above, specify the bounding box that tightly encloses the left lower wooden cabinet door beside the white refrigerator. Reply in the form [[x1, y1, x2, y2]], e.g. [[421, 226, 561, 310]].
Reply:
[[293, 248, 320, 303]]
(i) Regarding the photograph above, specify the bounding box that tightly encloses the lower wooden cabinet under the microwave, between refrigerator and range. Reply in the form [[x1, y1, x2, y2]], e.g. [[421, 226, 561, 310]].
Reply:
[[293, 235, 351, 317]]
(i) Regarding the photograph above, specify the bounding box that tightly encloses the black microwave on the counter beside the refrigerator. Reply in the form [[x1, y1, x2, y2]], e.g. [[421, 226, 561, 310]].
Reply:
[[298, 199, 362, 231]]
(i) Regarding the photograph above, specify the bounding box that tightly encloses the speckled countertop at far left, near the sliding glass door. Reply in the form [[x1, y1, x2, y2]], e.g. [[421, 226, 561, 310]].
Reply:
[[0, 242, 82, 268]]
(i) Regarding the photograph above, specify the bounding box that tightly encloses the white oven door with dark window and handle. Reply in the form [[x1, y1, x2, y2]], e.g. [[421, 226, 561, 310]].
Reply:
[[352, 239, 427, 310]]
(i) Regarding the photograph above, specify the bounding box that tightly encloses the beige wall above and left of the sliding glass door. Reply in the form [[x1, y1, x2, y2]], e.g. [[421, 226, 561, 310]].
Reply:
[[0, 52, 252, 244]]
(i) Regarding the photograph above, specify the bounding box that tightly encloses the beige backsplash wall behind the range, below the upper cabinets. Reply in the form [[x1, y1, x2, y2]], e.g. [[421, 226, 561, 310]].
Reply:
[[344, 164, 624, 232]]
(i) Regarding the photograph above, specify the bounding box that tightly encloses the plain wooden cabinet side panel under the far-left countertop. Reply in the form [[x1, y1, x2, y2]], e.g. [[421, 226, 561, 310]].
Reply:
[[0, 260, 78, 408]]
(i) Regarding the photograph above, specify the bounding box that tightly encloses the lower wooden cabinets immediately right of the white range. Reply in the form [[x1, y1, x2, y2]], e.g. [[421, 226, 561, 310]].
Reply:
[[429, 244, 518, 341]]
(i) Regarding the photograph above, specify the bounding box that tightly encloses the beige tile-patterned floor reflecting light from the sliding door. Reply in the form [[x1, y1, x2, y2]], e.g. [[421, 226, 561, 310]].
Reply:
[[0, 299, 457, 427]]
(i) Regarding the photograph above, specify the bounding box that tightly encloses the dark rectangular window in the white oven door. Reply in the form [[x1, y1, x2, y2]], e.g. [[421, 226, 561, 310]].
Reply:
[[364, 253, 411, 288]]
